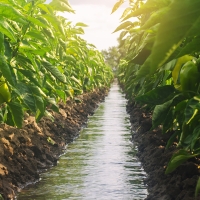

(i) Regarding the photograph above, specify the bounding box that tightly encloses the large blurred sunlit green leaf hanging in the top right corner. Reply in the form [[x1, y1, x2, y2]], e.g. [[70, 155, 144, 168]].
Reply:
[[150, 0, 200, 74]]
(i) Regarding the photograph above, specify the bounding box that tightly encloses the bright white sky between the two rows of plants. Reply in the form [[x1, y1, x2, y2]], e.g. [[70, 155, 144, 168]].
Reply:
[[47, 0, 128, 50]]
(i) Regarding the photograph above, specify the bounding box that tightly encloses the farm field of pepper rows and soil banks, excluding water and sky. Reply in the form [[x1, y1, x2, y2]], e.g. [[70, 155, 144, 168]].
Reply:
[[0, 0, 200, 200]]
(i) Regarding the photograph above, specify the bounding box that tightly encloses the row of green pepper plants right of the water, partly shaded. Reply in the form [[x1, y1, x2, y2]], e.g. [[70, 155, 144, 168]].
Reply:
[[113, 0, 200, 194]]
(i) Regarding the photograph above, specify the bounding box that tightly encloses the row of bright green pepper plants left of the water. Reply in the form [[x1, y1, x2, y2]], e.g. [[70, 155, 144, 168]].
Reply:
[[0, 0, 113, 127]]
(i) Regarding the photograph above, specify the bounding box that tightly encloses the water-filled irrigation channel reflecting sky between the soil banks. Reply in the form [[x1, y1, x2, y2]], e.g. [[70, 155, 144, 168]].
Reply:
[[17, 83, 147, 200]]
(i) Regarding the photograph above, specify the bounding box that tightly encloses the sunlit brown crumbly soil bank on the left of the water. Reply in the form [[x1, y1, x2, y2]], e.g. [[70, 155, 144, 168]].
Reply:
[[0, 89, 108, 200]]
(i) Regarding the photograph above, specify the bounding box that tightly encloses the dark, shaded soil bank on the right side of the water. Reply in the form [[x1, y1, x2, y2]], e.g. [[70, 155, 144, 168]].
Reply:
[[127, 102, 200, 200]]
